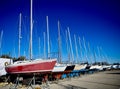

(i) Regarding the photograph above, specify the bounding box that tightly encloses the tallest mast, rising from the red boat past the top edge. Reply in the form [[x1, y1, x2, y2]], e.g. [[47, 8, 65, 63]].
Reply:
[[30, 0, 33, 60]]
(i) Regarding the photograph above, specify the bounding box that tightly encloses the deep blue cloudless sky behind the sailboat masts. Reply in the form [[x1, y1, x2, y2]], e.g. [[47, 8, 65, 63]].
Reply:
[[0, 0, 120, 62]]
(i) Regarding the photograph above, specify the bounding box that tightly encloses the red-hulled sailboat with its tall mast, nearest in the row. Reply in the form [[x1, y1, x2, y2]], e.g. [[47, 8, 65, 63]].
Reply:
[[5, 0, 56, 74]]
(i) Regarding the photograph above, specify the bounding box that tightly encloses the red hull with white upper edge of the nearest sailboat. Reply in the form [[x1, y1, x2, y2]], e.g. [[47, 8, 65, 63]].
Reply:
[[5, 59, 56, 74]]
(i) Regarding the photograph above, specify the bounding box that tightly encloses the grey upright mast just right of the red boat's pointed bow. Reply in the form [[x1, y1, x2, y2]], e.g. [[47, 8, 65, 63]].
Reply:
[[58, 21, 62, 63]]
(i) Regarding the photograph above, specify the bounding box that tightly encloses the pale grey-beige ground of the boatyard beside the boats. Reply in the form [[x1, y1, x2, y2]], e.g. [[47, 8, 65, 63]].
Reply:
[[0, 70, 120, 89]]
